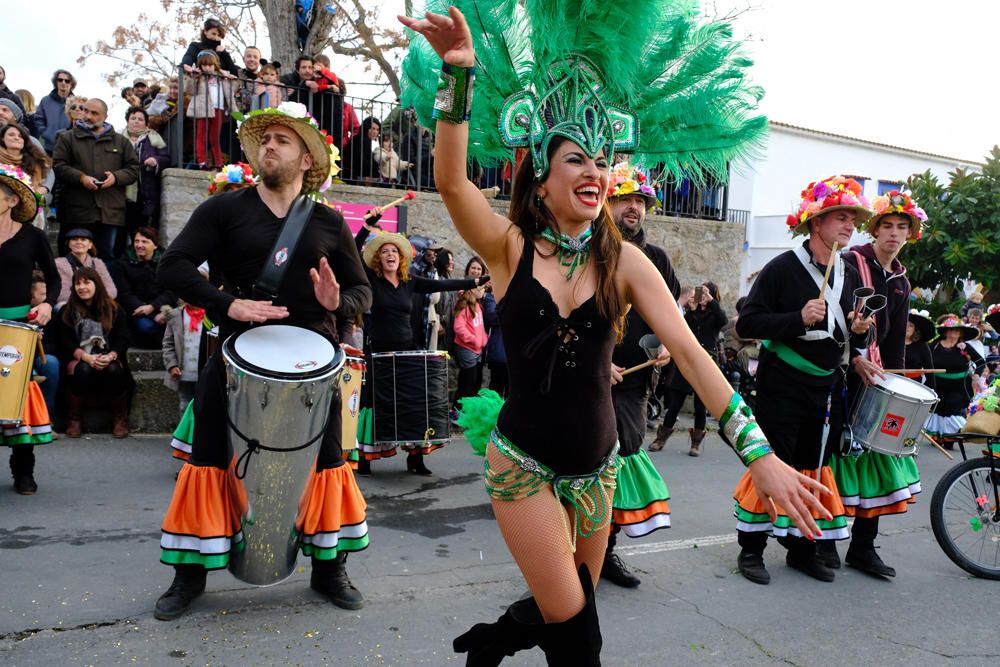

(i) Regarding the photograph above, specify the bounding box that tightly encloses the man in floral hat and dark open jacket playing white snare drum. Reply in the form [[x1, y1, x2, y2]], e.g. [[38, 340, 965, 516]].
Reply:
[[820, 190, 927, 577]]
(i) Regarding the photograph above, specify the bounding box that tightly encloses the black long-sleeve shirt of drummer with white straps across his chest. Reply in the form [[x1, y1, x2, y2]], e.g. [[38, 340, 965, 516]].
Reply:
[[736, 240, 864, 386]]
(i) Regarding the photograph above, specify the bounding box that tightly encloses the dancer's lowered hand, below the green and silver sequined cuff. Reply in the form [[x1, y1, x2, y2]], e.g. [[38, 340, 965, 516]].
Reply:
[[750, 454, 833, 539]]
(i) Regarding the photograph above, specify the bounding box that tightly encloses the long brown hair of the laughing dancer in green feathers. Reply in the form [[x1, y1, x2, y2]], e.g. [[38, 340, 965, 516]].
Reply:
[[507, 137, 625, 340]]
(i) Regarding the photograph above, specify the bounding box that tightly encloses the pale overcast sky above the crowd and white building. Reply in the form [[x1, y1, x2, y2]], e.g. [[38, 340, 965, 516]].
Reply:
[[0, 0, 1000, 160]]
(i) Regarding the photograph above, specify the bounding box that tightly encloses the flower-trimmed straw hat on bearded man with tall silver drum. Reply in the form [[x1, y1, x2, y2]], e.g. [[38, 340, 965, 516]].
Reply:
[[233, 102, 340, 194]]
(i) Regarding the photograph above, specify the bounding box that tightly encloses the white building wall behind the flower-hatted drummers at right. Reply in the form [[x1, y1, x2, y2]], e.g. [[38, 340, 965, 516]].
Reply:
[[729, 123, 979, 294]]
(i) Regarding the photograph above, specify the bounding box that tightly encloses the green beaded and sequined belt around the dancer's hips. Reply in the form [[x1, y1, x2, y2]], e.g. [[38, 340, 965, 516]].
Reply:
[[484, 429, 621, 545]]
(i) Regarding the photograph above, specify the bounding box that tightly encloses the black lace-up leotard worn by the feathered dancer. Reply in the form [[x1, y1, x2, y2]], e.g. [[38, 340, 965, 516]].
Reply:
[[497, 239, 617, 475]]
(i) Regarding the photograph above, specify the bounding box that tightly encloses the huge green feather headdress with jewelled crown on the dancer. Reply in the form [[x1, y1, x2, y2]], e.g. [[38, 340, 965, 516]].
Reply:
[[402, 0, 767, 183]]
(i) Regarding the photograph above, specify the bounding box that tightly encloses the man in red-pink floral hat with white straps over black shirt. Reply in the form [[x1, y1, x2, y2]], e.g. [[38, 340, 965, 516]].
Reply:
[[734, 176, 875, 584]]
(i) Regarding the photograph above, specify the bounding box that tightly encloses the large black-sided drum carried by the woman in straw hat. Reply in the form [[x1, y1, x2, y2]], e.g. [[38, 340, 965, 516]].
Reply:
[[371, 350, 450, 445]]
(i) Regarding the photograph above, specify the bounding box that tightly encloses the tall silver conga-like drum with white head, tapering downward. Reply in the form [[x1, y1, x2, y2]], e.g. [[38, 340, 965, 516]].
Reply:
[[222, 325, 344, 586]]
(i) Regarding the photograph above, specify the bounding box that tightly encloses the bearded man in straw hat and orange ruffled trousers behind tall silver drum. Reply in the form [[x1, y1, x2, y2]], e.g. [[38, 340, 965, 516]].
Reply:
[[155, 103, 371, 620]]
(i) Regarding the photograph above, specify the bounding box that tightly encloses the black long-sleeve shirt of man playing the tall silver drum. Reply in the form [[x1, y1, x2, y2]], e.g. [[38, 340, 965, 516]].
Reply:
[[158, 188, 372, 337]]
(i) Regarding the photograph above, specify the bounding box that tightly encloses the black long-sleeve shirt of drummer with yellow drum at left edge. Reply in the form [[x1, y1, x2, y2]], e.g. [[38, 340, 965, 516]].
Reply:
[[0, 223, 62, 308]]
